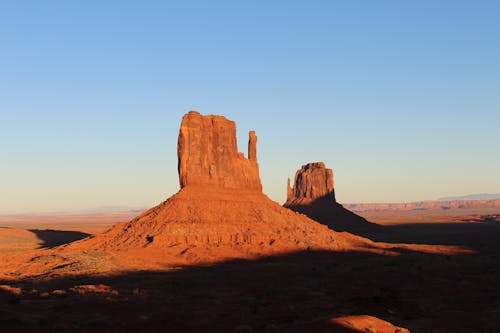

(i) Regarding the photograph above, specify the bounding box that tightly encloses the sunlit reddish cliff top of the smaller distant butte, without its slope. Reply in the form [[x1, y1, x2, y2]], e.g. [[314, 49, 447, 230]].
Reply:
[[287, 162, 335, 202]]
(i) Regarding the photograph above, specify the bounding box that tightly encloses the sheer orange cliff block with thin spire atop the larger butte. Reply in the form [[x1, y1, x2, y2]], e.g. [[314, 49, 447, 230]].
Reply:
[[177, 111, 262, 192]]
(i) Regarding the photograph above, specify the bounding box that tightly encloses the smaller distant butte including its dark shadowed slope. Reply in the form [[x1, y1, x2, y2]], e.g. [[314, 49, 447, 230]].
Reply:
[[284, 162, 380, 234]]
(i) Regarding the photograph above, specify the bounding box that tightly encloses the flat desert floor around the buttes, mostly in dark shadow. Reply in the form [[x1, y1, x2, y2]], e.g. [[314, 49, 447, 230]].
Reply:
[[0, 212, 500, 333]]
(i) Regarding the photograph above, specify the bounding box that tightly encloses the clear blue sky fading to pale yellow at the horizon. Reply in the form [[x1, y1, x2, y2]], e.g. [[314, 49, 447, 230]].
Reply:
[[0, 0, 500, 213]]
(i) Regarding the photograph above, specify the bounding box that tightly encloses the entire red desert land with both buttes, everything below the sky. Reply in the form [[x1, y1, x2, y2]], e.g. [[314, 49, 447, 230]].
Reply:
[[0, 111, 500, 333]]
